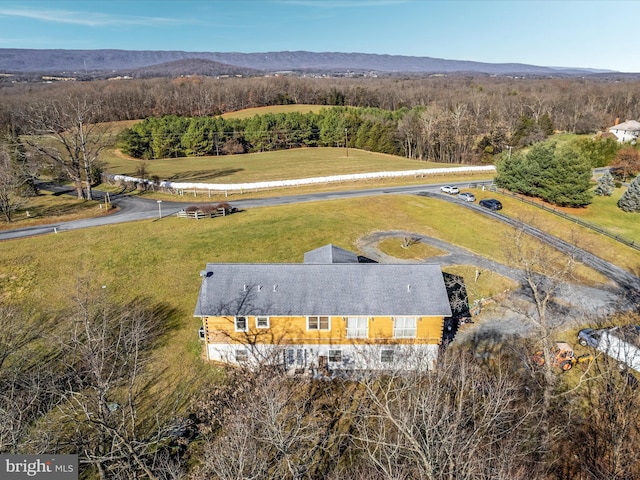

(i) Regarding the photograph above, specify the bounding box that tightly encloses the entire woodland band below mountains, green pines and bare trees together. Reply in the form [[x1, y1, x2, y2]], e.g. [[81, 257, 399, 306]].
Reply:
[[0, 73, 640, 216]]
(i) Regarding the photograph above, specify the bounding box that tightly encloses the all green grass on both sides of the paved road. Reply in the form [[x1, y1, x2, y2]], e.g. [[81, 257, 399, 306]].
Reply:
[[5, 107, 640, 448]]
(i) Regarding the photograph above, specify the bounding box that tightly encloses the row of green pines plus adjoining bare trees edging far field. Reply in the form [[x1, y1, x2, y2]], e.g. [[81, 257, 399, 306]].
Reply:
[[118, 106, 554, 163]]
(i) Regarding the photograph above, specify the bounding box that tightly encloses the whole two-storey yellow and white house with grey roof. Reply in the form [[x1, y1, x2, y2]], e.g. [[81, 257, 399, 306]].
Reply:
[[194, 245, 452, 373]]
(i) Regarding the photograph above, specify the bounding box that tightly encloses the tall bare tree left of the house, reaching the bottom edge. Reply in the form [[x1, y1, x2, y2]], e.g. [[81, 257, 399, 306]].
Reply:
[[52, 289, 184, 479]]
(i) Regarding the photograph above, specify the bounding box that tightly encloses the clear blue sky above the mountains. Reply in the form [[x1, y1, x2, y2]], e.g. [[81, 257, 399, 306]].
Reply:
[[0, 0, 640, 72]]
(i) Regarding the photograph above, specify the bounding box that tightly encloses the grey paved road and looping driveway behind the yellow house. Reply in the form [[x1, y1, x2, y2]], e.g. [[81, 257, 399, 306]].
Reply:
[[0, 181, 640, 338]]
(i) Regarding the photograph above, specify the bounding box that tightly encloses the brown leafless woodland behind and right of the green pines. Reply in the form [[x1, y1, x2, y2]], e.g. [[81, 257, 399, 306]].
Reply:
[[0, 76, 640, 161]]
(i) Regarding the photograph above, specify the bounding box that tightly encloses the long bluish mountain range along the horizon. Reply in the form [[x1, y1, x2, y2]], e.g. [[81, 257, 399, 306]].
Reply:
[[0, 48, 618, 78]]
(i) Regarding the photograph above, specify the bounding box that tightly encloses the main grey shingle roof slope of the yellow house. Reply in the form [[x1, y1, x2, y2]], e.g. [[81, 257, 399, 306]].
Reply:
[[194, 263, 451, 316]]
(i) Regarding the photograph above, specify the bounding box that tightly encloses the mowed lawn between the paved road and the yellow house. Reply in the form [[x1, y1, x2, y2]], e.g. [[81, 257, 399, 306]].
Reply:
[[0, 195, 624, 368]]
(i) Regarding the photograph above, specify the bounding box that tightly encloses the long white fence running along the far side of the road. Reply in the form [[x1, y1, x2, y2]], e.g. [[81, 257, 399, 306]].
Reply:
[[113, 165, 496, 193]]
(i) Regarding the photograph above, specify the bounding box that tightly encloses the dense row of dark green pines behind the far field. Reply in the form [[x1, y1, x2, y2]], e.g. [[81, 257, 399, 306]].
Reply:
[[117, 107, 403, 159]]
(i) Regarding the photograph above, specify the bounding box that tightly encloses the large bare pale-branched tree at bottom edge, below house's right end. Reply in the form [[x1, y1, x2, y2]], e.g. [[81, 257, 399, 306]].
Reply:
[[352, 351, 536, 479]]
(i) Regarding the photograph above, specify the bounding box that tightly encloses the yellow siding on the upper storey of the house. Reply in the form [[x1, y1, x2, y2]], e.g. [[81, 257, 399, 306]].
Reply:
[[203, 316, 444, 345]]
